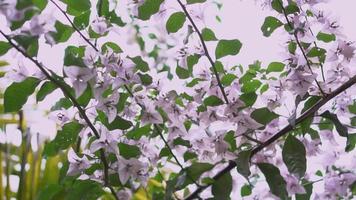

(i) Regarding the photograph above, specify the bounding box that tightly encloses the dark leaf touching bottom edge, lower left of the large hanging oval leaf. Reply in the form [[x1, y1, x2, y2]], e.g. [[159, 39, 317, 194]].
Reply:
[[257, 163, 288, 199]]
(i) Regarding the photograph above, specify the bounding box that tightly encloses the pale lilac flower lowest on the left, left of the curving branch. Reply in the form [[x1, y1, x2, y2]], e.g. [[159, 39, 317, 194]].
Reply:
[[67, 148, 91, 176]]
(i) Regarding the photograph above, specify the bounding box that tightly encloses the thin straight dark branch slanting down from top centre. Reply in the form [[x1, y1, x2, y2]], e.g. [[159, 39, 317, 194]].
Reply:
[[177, 0, 229, 104]]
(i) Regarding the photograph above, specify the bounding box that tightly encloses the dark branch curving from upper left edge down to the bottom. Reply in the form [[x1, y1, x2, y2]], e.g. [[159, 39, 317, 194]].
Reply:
[[0, 30, 118, 200]]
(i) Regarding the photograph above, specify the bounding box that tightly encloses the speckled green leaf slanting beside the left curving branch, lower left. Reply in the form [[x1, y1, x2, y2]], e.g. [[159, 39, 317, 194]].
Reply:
[[43, 122, 83, 156]]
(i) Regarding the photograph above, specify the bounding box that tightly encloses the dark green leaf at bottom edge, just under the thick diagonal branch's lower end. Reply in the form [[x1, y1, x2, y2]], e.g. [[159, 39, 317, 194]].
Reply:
[[211, 172, 232, 200]]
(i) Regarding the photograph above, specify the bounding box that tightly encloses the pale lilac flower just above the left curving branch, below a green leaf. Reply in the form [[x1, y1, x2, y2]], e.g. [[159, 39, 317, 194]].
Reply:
[[64, 66, 95, 97]]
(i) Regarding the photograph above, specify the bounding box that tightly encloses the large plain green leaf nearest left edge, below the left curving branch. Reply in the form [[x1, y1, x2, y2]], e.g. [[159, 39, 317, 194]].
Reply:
[[4, 77, 40, 112]]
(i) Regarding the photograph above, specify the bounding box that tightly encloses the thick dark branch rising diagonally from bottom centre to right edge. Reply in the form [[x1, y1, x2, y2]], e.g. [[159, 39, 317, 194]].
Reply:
[[186, 76, 356, 200]]
